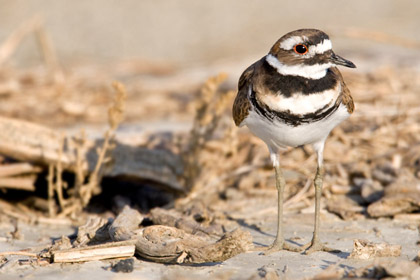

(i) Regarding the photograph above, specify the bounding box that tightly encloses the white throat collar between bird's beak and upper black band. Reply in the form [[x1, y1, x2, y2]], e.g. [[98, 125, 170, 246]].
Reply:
[[265, 54, 333, 80]]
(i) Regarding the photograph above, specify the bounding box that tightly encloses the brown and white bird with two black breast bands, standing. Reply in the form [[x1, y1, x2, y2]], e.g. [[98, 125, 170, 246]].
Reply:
[[232, 29, 356, 254]]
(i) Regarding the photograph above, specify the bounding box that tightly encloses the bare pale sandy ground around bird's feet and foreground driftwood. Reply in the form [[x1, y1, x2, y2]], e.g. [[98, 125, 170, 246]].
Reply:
[[0, 207, 419, 279]]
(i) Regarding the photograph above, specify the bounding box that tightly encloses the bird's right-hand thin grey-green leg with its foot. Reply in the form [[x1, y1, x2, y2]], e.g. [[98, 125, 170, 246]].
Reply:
[[303, 162, 341, 255]]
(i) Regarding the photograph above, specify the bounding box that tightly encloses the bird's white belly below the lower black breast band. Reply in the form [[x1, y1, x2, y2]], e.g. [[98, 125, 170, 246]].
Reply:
[[243, 104, 350, 151]]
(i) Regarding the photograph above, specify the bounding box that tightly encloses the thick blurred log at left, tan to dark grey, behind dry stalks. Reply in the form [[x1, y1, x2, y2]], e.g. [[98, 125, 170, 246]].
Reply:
[[0, 117, 183, 192]]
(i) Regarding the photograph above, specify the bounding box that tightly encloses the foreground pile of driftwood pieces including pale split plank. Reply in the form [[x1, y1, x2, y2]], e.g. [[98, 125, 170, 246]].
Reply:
[[44, 206, 253, 263]]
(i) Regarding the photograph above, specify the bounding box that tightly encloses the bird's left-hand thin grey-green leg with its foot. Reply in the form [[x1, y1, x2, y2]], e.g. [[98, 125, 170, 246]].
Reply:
[[264, 163, 302, 255]]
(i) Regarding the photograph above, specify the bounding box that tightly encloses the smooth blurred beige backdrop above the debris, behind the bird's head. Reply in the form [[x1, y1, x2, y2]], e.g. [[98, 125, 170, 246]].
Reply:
[[0, 0, 420, 70]]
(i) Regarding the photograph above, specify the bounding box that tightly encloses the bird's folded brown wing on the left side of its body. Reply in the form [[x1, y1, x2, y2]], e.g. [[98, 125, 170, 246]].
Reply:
[[232, 63, 255, 126]]
